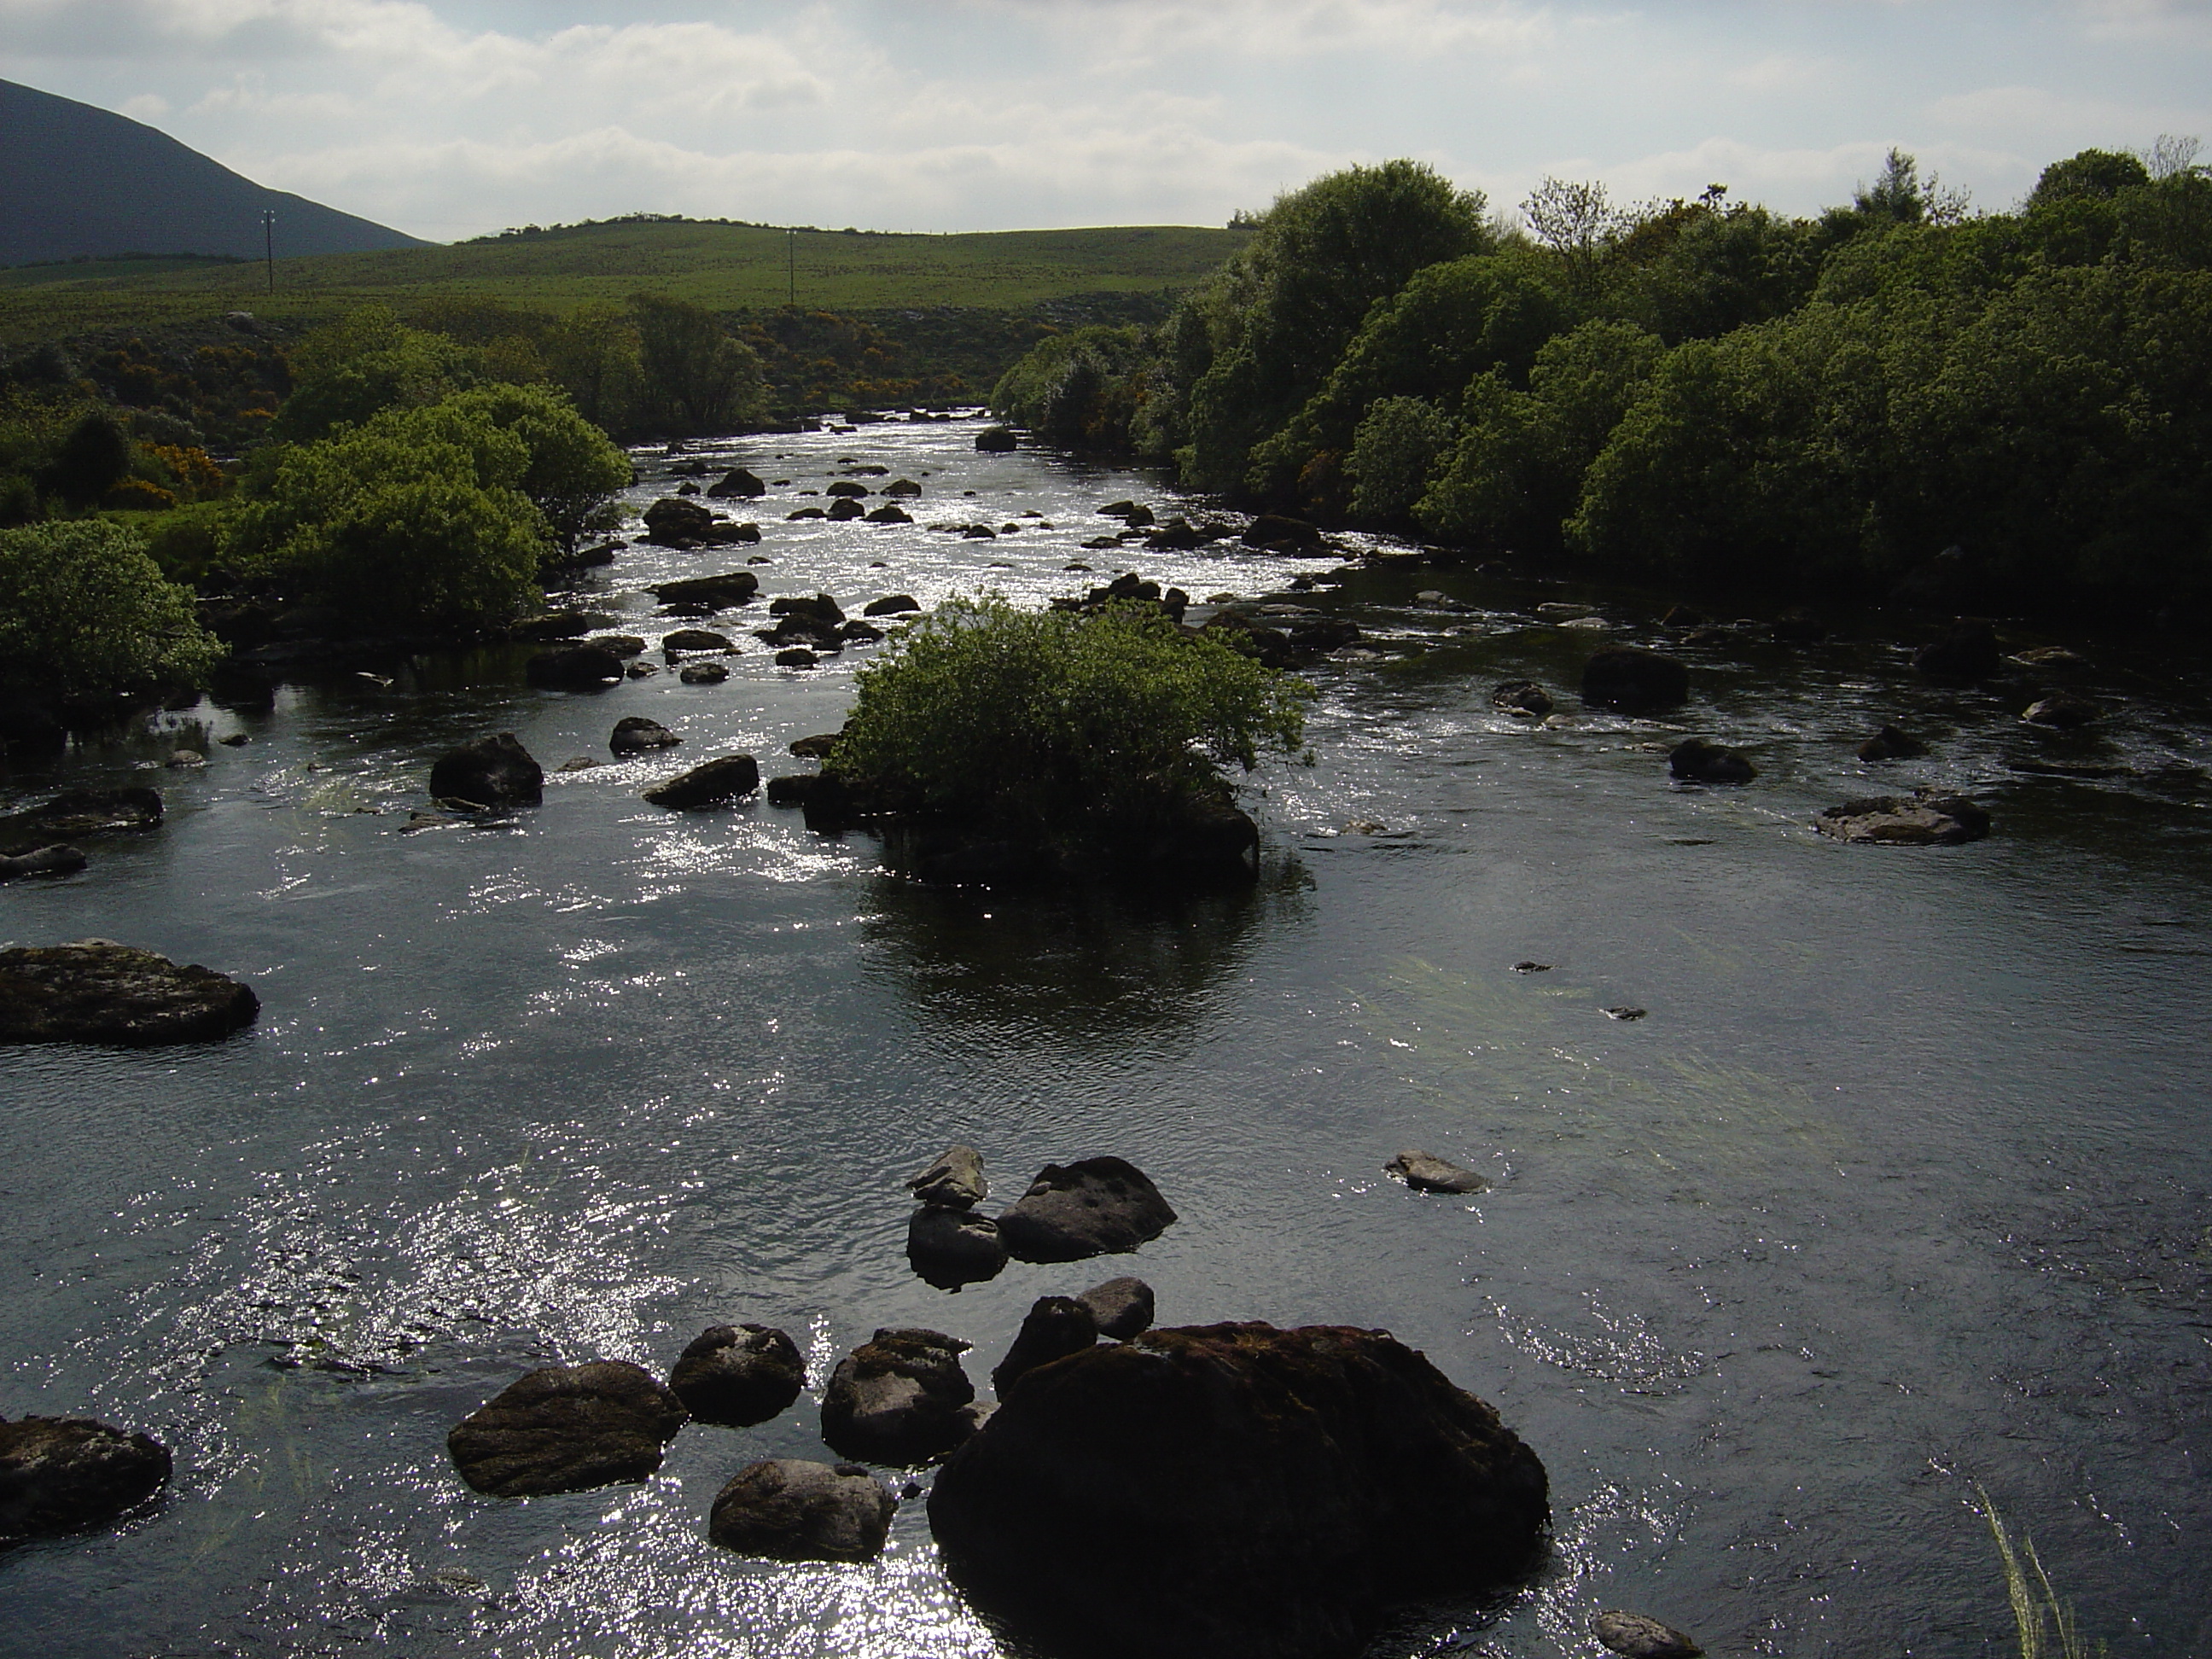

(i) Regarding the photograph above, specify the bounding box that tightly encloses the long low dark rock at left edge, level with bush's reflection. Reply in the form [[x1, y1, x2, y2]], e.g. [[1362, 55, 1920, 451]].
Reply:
[[0, 940, 261, 1049]]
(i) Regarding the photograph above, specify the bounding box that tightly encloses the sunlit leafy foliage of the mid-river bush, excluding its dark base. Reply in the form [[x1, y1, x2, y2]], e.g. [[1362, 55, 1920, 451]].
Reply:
[[830, 597, 1312, 836]]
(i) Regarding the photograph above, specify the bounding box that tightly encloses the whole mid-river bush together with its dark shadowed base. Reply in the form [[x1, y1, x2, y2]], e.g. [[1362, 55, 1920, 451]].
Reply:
[[816, 597, 1314, 881]]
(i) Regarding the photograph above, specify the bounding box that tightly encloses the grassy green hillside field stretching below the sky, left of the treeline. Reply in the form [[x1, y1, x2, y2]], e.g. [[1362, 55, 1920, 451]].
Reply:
[[0, 221, 1248, 341]]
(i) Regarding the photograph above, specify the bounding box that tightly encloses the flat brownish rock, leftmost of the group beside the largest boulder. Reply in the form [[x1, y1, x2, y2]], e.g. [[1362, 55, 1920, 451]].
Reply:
[[445, 1360, 686, 1498]]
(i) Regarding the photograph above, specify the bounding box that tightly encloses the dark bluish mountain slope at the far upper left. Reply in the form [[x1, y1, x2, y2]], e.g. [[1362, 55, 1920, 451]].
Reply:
[[0, 79, 429, 265]]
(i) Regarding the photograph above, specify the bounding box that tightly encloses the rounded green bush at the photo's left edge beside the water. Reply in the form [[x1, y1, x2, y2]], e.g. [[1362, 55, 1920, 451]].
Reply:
[[0, 520, 224, 701]]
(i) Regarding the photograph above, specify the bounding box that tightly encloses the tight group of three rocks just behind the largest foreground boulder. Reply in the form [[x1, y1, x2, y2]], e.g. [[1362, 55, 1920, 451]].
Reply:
[[907, 1146, 1174, 1289]]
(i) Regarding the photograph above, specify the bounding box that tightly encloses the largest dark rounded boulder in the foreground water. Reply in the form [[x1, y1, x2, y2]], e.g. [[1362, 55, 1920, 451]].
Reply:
[[929, 1325, 1548, 1659]]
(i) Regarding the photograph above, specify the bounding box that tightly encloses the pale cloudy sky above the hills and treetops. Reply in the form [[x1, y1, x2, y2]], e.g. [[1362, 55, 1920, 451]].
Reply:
[[0, 0, 2212, 242]]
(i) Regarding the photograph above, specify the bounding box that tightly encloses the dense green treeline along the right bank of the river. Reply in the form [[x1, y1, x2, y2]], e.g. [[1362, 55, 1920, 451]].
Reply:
[[993, 142, 2212, 602]]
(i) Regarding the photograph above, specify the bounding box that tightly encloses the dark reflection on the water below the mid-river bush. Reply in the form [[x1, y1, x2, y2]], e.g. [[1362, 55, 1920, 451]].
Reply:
[[863, 860, 1312, 1046]]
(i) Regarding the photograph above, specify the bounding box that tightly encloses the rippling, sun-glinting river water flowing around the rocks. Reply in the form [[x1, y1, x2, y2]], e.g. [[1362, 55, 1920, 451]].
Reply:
[[0, 422, 2212, 1659]]
